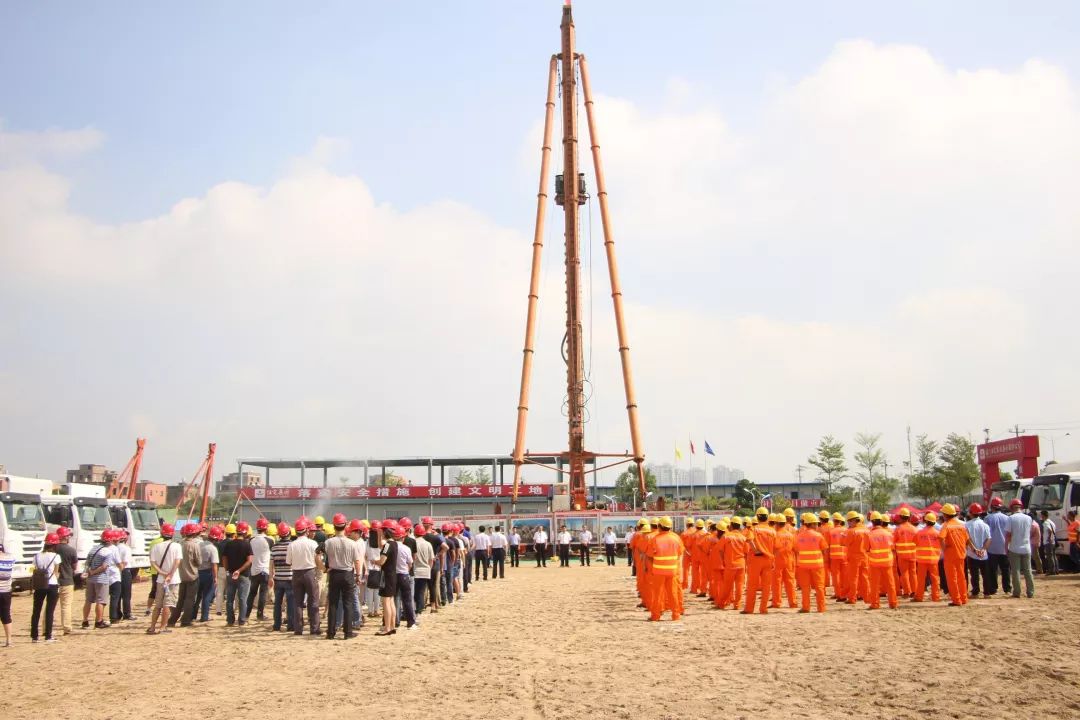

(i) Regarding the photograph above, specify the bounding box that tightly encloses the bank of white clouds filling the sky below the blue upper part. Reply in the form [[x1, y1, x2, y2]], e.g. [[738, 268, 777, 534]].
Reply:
[[0, 41, 1080, 487]]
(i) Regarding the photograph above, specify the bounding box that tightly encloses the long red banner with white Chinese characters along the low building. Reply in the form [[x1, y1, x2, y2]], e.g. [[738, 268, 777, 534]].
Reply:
[[240, 485, 553, 500]]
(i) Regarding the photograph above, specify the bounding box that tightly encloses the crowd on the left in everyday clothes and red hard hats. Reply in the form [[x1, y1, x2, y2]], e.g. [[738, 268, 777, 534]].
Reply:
[[0, 513, 517, 644]]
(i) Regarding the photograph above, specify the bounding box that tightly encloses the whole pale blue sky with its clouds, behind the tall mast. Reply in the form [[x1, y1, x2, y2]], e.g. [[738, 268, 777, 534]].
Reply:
[[0, 0, 1080, 487]]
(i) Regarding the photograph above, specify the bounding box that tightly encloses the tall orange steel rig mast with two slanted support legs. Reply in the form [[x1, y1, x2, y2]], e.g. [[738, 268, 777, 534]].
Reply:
[[512, 0, 645, 510]]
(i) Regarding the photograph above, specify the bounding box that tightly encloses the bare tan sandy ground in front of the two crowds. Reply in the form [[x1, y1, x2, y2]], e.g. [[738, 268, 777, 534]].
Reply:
[[0, 563, 1080, 720]]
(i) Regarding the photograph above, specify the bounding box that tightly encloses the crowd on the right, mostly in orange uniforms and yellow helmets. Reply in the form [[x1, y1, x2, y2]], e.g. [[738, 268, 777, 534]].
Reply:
[[626, 498, 1080, 621]]
